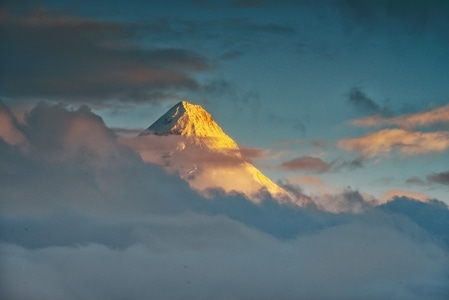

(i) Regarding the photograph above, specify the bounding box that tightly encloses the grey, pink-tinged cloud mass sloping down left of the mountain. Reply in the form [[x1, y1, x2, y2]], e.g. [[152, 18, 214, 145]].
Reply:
[[0, 104, 195, 213]]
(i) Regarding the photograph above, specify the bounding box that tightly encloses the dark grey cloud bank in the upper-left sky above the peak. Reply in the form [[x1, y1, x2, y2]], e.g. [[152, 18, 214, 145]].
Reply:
[[0, 7, 210, 101]]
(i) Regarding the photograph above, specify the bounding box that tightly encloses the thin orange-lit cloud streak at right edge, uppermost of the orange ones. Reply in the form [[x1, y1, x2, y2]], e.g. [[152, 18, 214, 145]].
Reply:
[[351, 104, 449, 128]]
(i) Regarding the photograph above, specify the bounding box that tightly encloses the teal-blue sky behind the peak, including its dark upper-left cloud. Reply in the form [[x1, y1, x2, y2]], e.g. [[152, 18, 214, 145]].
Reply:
[[1, 0, 449, 202]]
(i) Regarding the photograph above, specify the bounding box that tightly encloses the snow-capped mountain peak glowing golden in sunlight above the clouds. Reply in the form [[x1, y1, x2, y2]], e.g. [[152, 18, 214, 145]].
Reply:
[[139, 101, 288, 202]]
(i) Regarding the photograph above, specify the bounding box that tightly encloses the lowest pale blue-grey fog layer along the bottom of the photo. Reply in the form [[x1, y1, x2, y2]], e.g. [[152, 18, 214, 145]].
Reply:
[[0, 210, 448, 299]]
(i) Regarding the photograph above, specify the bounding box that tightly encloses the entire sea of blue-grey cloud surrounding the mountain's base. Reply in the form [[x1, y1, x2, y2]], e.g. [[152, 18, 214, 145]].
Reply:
[[0, 103, 449, 300]]
